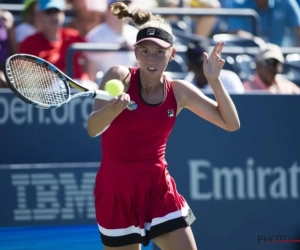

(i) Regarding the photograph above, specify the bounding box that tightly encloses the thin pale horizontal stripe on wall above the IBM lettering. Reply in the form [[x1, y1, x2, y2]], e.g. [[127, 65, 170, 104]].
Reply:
[[0, 162, 100, 170]]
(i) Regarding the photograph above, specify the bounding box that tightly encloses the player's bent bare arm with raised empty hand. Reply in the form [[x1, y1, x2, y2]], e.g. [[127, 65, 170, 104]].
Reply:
[[172, 43, 240, 131]]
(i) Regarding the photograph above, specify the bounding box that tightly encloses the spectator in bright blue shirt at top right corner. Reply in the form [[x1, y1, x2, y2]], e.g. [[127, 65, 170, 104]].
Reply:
[[228, 0, 300, 46]]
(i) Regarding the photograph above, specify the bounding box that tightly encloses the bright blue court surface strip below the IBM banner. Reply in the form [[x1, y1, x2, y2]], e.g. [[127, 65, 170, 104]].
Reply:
[[0, 225, 152, 250]]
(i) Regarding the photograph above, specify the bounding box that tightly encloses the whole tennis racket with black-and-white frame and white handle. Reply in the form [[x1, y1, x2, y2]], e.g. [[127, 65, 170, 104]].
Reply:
[[4, 54, 137, 110]]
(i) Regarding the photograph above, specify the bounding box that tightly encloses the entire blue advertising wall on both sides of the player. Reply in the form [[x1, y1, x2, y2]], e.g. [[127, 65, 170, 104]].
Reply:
[[0, 90, 300, 250]]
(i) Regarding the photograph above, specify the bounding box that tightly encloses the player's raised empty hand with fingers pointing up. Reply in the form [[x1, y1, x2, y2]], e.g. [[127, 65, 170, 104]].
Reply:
[[203, 42, 225, 83]]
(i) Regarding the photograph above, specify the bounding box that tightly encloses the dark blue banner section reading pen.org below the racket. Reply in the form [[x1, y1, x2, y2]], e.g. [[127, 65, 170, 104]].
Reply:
[[0, 92, 101, 164]]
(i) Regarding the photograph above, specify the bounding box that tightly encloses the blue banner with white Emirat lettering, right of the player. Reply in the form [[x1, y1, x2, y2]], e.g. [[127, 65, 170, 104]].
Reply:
[[167, 96, 300, 250]]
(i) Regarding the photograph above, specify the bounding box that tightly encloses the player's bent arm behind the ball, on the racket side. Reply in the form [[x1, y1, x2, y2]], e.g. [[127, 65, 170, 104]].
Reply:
[[87, 66, 130, 137]]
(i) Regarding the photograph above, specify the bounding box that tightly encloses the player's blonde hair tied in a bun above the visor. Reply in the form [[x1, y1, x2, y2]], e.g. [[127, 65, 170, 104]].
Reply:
[[110, 2, 173, 35]]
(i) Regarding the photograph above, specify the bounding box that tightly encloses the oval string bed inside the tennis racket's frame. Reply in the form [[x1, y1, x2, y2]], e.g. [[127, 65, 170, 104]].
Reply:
[[7, 58, 69, 105]]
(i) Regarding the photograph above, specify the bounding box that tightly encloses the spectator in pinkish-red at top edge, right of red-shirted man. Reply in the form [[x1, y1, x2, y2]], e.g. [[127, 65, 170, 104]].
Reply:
[[66, 0, 106, 37]]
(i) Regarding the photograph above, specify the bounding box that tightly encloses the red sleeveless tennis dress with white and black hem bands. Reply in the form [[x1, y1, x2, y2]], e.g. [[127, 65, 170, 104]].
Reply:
[[94, 68, 195, 247]]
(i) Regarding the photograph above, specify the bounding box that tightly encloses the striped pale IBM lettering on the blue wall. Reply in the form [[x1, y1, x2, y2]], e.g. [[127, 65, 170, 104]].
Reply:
[[11, 172, 96, 221]]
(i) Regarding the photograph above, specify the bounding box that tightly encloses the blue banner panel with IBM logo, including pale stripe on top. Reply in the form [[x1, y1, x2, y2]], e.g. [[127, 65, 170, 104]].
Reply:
[[0, 163, 99, 226]]
